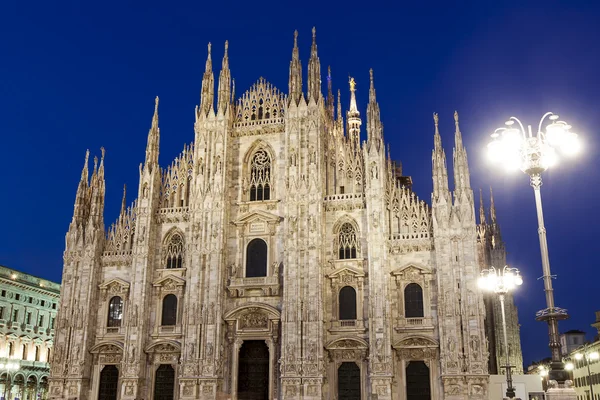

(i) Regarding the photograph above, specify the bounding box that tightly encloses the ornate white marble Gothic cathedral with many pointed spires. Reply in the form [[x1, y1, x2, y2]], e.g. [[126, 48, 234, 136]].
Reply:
[[49, 28, 522, 400]]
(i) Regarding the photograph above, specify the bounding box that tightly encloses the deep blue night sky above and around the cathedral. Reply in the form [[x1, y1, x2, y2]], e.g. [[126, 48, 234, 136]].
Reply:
[[0, 0, 600, 365]]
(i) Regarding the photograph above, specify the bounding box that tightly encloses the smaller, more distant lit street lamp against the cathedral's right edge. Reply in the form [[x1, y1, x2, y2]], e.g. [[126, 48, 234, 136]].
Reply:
[[477, 265, 523, 399]]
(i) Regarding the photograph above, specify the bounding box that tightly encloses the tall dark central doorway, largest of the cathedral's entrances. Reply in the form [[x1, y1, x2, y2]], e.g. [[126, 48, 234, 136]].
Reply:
[[237, 340, 269, 400]]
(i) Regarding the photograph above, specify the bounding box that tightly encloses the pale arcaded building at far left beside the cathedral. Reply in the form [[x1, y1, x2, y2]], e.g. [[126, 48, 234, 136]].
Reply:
[[0, 266, 60, 400]]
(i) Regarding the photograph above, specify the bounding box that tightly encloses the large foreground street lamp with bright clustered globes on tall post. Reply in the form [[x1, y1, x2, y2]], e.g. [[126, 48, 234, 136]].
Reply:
[[488, 112, 581, 383]]
